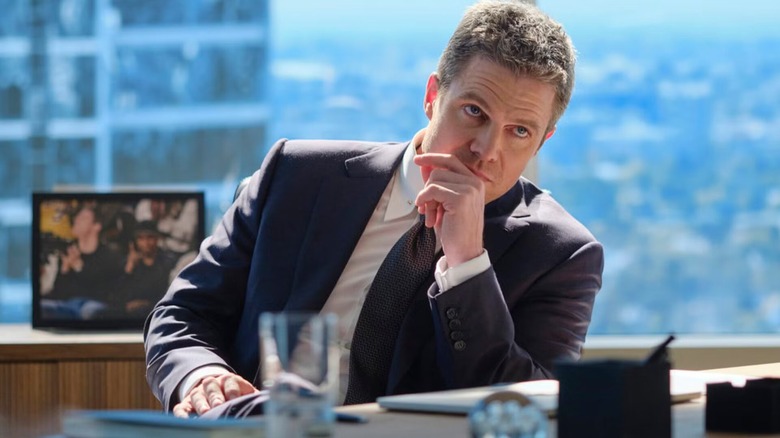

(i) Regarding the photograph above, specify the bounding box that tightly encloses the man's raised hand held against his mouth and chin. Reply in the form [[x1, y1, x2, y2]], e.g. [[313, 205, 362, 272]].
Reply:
[[414, 153, 485, 267]]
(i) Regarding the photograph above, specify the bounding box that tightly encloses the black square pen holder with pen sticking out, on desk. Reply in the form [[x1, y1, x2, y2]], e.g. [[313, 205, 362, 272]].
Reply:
[[556, 360, 672, 438]]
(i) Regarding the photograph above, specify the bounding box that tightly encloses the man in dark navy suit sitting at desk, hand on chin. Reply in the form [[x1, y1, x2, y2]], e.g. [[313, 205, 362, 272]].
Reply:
[[145, 2, 603, 416]]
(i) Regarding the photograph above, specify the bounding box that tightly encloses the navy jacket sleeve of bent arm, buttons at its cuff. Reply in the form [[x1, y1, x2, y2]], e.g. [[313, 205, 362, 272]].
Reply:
[[429, 240, 604, 388]]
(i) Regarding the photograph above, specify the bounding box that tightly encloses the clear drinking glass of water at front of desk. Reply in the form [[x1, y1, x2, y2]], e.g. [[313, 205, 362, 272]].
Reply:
[[260, 313, 339, 438]]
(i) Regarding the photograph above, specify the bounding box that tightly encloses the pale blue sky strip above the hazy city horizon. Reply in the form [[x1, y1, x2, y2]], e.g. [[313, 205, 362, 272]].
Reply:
[[271, 0, 780, 40]]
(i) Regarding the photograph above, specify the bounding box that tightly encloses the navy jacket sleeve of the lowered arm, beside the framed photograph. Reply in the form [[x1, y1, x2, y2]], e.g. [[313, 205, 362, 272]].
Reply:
[[144, 140, 285, 411]]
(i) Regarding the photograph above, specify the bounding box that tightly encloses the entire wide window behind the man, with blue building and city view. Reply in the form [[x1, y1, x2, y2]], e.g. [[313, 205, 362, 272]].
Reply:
[[0, 0, 780, 334]]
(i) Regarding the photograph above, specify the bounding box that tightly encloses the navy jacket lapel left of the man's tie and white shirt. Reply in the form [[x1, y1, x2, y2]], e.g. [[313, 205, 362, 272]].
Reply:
[[286, 143, 408, 311]]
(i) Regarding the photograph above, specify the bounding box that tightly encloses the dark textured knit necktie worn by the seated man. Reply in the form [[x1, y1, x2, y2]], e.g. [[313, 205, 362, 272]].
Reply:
[[344, 216, 436, 405]]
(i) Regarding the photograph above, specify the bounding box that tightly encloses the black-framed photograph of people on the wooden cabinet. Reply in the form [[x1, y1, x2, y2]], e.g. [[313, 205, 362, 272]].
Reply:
[[31, 192, 205, 330]]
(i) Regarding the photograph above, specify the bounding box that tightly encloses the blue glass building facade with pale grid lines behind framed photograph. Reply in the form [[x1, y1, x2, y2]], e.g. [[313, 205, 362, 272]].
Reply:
[[0, 0, 269, 322]]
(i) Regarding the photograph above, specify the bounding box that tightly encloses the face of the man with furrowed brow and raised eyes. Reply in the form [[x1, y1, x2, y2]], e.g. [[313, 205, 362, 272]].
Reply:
[[422, 57, 555, 203]]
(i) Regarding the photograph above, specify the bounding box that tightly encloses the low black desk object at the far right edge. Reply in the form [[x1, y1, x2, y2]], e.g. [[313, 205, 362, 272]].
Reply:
[[705, 378, 780, 433]]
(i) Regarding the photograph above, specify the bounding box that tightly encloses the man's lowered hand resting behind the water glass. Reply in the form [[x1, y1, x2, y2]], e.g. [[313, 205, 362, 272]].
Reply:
[[173, 373, 259, 418]]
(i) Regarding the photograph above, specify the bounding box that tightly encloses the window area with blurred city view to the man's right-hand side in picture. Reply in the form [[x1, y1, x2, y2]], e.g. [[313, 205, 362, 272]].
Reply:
[[539, 0, 780, 334]]
